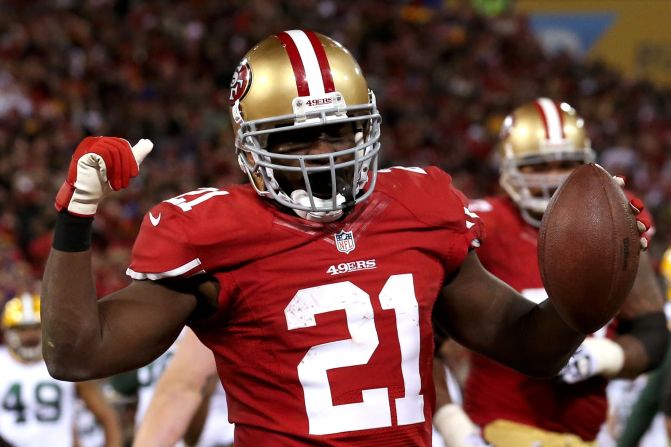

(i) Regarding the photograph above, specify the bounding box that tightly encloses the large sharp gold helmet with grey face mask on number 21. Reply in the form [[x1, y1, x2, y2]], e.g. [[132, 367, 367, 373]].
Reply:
[[228, 30, 381, 221]]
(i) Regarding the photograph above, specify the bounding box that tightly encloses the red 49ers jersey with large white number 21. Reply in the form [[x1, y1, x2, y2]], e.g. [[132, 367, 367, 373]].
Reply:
[[128, 168, 480, 447]]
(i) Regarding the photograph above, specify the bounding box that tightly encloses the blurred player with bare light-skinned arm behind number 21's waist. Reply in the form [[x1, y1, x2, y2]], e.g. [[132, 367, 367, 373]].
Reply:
[[133, 330, 233, 447]]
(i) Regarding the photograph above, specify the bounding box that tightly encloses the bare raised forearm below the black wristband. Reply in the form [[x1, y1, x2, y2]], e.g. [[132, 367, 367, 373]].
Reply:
[[41, 249, 101, 380]]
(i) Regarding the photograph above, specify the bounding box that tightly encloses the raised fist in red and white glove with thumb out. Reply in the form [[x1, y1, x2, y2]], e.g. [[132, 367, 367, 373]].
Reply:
[[55, 137, 154, 217]]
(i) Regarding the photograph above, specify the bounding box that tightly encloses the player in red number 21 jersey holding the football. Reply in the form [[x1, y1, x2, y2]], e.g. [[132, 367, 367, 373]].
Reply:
[[43, 30, 643, 447]]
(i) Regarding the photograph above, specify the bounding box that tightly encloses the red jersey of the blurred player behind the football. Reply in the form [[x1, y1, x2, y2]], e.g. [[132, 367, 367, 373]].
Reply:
[[464, 196, 649, 441]]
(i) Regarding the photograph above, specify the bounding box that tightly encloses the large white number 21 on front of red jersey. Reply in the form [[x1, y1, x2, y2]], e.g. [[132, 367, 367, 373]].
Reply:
[[284, 274, 424, 435]]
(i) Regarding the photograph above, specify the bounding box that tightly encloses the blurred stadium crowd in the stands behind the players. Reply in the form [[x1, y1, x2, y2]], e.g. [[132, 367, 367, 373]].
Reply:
[[0, 0, 671, 444]]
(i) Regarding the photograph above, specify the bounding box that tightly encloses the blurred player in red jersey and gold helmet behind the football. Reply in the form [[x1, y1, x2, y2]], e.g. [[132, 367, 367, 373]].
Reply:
[[434, 98, 667, 447]]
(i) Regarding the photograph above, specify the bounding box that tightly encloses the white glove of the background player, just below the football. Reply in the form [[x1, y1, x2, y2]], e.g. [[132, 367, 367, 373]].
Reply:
[[559, 337, 624, 383]]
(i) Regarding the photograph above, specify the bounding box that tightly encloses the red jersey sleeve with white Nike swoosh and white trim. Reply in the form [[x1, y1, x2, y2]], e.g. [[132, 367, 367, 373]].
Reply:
[[126, 202, 202, 280]]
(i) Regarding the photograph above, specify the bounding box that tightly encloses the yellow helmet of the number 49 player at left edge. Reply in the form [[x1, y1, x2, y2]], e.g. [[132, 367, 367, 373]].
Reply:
[[2, 293, 42, 362]]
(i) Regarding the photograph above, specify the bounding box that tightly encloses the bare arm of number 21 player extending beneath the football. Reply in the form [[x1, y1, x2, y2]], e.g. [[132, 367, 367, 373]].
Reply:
[[433, 255, 585, 377]]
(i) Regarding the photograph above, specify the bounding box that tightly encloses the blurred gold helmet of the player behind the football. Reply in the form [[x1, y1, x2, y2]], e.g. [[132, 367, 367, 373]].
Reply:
[[498, 98, 595, 226]]
